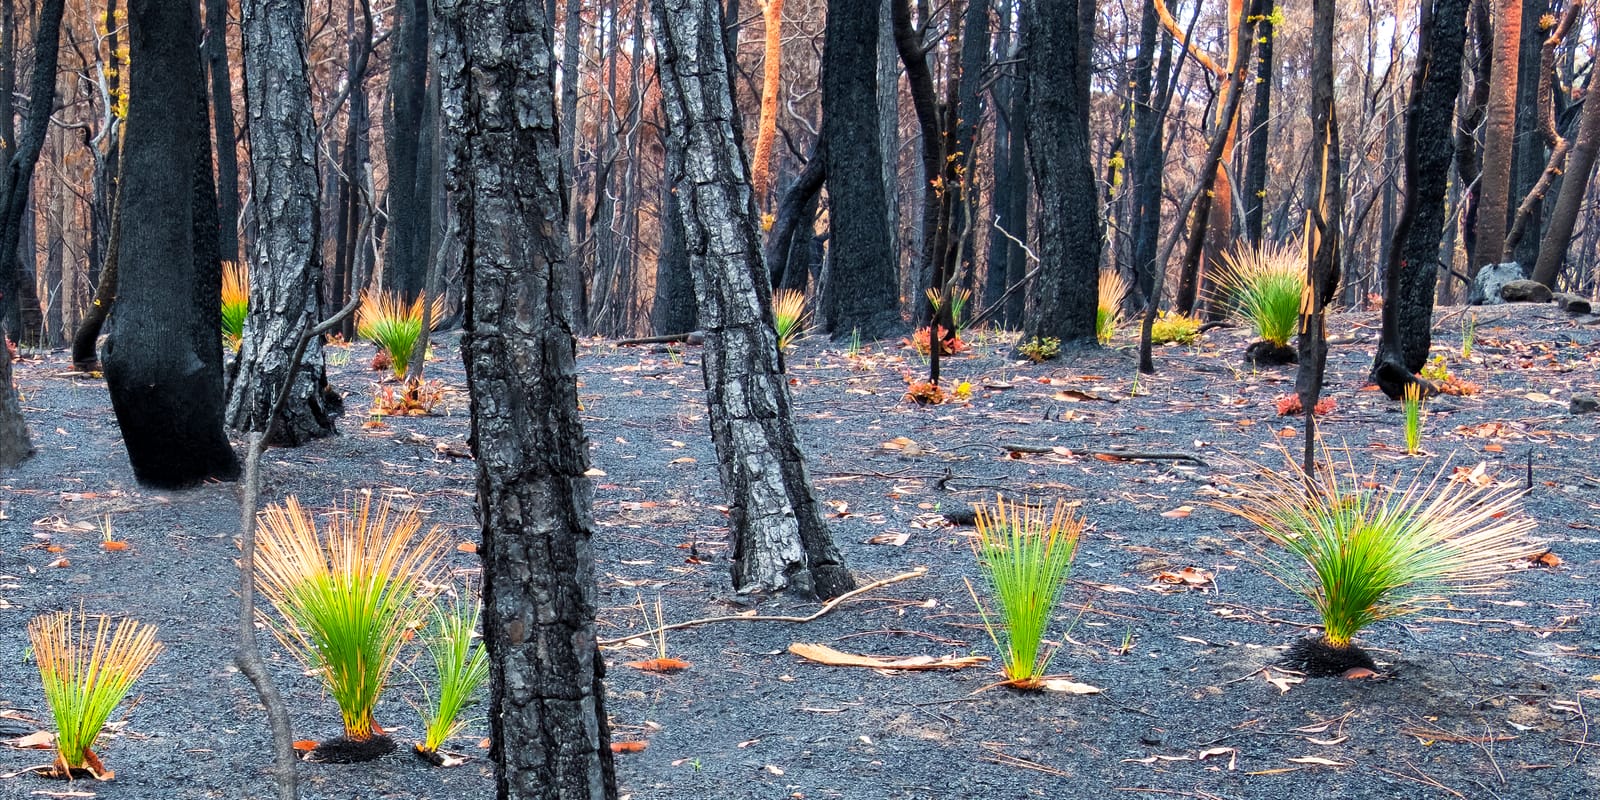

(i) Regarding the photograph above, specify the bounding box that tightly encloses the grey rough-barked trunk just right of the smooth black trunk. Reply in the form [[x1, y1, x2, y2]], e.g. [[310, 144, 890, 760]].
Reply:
[[227, 0, 338, 446]]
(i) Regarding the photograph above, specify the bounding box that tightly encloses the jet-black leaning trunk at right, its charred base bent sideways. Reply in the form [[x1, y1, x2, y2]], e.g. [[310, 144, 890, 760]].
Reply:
[[1371, 0, 1470, 397]]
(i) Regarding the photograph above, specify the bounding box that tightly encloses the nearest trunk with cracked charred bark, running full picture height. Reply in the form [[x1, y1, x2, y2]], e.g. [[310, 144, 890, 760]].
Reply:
[[434, 0, 616, 800]]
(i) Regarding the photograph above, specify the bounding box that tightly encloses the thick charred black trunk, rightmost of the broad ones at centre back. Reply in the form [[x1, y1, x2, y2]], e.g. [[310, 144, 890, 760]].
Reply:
[[1022, 0, 1101, 344]]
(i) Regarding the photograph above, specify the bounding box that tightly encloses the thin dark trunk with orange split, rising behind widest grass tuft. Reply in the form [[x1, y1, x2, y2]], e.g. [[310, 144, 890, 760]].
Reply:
[[1292, 0, 1344, 475]]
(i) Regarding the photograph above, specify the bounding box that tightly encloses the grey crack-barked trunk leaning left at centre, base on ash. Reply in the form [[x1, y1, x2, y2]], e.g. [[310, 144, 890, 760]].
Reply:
[[651, 0, 857, 597]]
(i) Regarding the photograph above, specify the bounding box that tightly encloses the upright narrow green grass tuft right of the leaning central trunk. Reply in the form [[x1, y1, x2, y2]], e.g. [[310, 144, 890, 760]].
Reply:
[[966, 496, 1083, 688]]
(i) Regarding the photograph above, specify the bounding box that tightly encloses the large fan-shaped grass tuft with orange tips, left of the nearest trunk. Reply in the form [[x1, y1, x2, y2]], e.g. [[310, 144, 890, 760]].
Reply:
[[256, 494, 443, 762]]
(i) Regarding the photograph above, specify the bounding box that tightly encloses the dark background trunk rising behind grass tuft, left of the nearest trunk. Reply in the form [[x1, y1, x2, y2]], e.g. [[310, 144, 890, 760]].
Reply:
[[382, 0, 434, 302]]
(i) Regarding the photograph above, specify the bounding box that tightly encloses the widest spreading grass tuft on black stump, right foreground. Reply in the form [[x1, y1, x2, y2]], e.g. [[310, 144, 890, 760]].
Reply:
[[1218, 453, 1539, 675]]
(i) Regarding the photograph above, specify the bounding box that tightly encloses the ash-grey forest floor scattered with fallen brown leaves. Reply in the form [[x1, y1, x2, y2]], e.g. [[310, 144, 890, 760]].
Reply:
[[0, 306, 1600, 800]]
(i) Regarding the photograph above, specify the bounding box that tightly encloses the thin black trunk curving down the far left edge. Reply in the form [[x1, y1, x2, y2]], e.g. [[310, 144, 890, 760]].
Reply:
[[0, 0, 66, 340]]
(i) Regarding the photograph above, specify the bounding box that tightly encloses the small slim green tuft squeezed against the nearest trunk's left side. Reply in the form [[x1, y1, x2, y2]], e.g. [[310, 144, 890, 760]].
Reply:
[[416, 597, 490, 765]]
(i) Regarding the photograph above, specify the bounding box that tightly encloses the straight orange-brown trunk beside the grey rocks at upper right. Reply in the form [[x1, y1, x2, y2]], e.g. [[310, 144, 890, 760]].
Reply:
[[1469, 0, 1522, 277]]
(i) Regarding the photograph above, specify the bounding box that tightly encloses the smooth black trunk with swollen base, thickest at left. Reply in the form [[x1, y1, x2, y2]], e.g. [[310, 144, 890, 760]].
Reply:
[[102, 0, 238, 488]]
